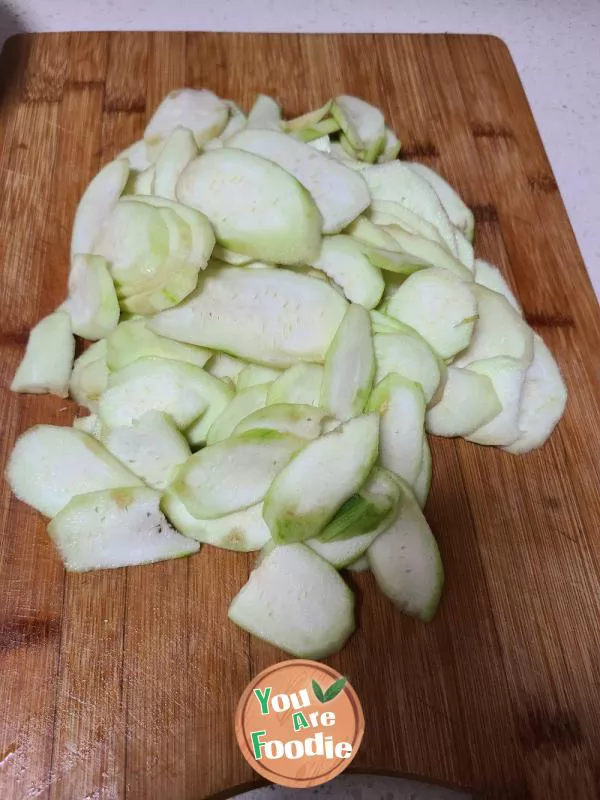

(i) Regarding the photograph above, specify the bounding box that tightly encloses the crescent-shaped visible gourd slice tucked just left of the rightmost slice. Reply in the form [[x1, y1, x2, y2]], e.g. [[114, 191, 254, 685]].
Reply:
[[465, 356, 525, 447]]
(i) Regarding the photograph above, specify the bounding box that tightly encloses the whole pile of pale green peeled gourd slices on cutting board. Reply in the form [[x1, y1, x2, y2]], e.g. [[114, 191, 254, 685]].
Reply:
[[7, 89, 566, 658]]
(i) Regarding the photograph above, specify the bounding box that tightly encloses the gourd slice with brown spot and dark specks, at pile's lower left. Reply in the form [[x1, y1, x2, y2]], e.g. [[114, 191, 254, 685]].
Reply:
[[48, 487, 200, 572]]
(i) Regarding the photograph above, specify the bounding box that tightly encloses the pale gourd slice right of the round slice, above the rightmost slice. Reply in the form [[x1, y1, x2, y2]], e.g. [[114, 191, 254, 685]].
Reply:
[[454, 283, 533, 368]]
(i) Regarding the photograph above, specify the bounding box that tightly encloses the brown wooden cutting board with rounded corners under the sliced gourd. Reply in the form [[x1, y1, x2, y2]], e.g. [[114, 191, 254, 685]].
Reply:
[[0, 33, 600, 800]]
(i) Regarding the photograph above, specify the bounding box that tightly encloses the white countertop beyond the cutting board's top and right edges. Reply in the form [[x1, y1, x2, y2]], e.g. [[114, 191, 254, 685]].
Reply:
[[0, 0, 600, 295]]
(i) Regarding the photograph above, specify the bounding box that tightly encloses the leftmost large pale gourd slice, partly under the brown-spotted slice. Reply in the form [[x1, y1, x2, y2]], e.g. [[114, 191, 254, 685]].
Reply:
[[6, 425, 142, 517]]
